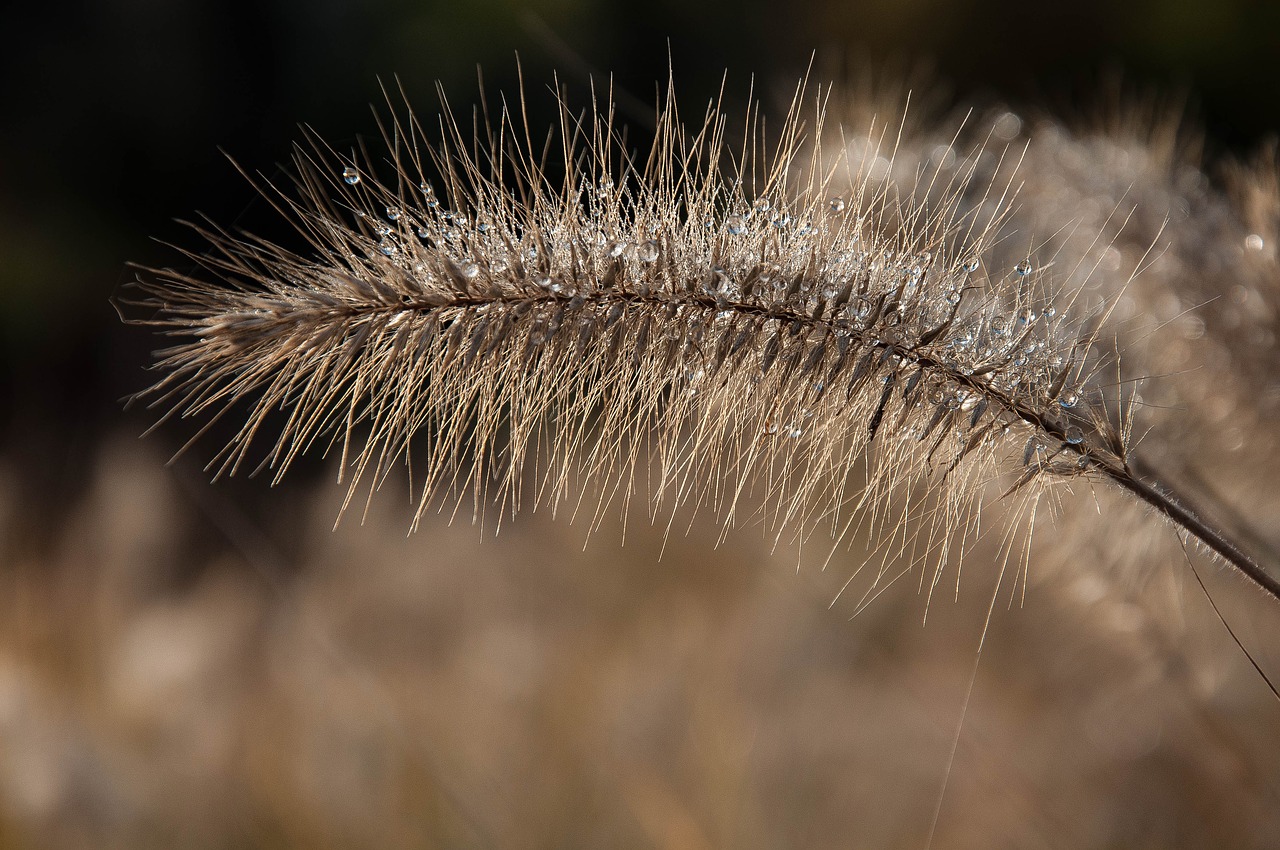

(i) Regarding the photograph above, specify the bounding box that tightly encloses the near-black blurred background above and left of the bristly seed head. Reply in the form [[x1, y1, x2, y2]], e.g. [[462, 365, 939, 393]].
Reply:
[[0, 0, 1280, 545]]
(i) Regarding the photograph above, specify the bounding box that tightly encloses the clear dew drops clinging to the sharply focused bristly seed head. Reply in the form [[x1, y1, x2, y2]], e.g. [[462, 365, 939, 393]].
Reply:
[[342, 165, 1087, 455]]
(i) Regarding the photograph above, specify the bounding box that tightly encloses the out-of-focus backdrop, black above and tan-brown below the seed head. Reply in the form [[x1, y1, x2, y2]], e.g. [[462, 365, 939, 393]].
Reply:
[[0, 0, 1280, 847]]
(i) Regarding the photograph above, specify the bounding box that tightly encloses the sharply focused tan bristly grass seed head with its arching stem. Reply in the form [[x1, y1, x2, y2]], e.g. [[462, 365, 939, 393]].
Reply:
[[131, 74, 1277, 604]]
